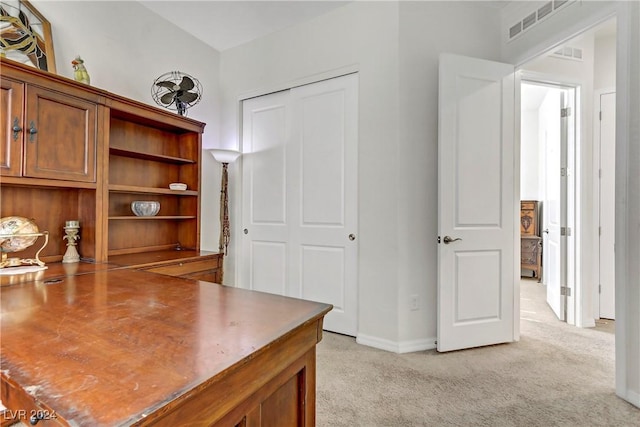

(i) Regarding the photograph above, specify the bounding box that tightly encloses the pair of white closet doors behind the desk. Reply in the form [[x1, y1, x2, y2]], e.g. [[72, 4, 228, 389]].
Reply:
[[241, 74, 358, 336]]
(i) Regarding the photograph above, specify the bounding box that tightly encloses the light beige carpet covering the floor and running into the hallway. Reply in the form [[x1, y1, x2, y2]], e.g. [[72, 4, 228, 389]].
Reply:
[[316, 280, 640, 427]]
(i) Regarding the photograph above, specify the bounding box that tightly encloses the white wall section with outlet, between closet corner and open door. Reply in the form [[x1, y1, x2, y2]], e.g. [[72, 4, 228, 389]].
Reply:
[[398, 1, 500, 351]]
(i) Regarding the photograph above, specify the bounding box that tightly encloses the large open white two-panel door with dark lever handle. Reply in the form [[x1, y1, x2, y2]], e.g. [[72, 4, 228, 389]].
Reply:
[[437, 54, 520, 351]]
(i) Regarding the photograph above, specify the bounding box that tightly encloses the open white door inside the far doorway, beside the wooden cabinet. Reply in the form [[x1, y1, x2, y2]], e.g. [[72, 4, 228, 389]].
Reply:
[[539, 89, 566, 320]]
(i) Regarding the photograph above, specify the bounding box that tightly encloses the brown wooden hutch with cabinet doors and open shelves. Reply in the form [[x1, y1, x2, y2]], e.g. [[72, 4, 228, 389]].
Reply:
[[0, 59, 221, 282]]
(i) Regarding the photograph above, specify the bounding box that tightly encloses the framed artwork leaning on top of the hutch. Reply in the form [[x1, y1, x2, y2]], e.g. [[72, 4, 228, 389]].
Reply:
[[0, 0, 56, 73]]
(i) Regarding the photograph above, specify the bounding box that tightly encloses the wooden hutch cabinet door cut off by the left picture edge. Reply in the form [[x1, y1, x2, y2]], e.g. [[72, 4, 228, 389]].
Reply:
[[0, 78, 24, 176]]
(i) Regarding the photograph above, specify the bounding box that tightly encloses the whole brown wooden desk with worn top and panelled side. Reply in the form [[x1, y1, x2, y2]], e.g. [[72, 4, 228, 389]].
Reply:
[[0, 269, 331, 427]]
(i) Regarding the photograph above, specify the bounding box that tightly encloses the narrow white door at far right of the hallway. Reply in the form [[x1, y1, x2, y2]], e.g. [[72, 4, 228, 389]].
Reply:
[[599, 92, 616, 319]]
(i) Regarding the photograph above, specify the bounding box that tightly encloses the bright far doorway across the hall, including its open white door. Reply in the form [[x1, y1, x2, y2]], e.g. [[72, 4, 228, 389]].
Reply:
[[520, 80, 579, 322]]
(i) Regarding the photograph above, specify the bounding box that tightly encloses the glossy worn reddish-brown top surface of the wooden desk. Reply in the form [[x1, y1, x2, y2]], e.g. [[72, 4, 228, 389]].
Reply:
[[0, 269, 331, 426]]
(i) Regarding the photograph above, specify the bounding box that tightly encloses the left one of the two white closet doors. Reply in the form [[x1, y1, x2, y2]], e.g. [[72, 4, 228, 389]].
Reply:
[[238, 91, 291, 295]]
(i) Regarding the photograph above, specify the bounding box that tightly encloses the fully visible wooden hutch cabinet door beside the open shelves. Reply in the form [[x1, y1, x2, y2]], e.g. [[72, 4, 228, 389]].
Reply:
[[24, 86, 98, 182]]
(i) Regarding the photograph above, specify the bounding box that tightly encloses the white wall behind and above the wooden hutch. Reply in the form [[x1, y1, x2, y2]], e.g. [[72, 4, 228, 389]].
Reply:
[[31, 0, 220, 251]]
